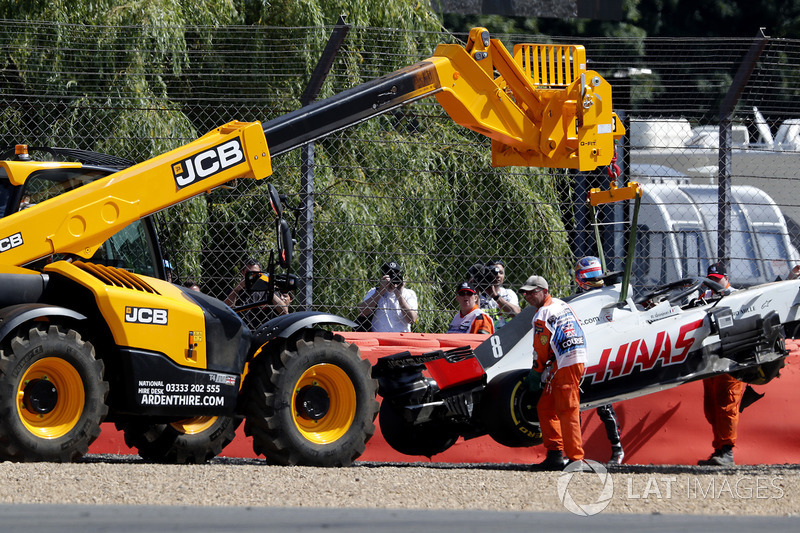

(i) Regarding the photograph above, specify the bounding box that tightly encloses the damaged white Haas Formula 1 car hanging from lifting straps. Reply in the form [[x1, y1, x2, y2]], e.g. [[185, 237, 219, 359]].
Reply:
[[372, 183, 800, 457]]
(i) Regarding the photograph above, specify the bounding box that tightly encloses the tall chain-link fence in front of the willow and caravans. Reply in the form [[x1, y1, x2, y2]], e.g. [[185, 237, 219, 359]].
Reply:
[[0, 21, 800, 332]]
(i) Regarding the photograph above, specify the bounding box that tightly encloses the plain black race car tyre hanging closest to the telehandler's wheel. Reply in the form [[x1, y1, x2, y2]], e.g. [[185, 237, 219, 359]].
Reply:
[[378, 400, 459, 459]]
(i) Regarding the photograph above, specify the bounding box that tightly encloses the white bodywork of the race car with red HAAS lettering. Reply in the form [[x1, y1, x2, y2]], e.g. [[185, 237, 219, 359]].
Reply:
[[486, 280, 800, 409]]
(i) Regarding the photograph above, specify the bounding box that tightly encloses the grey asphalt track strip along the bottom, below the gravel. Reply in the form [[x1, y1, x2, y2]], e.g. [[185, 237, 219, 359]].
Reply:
[[0, 504, 798, 533]]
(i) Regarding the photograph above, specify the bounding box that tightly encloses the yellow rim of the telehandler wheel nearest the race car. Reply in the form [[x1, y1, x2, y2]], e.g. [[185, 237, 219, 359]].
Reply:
[[292, 363, 356, 444]]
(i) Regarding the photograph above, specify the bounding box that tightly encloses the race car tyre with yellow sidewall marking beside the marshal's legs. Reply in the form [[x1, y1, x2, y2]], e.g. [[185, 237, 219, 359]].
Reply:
[[480, 370, 542, 448]]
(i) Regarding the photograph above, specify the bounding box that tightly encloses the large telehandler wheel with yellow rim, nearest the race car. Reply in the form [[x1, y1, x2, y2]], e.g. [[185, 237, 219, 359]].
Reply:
[[244, 330, 378, 466]]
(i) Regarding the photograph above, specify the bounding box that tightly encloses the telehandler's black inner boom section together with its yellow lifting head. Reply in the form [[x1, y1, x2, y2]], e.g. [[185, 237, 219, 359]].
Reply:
[[264, 28, 625, 166]]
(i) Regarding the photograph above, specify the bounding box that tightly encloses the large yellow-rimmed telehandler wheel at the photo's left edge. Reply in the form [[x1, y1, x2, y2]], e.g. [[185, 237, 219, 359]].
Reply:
[[0, 324, 109, 463]]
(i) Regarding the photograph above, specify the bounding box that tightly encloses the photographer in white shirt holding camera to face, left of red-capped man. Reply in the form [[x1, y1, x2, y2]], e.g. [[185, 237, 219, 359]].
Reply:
[[358, 261, 417, 332]]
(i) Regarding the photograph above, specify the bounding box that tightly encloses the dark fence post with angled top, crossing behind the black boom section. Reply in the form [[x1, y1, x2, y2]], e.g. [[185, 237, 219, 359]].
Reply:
[[298, 15, 350, 311]]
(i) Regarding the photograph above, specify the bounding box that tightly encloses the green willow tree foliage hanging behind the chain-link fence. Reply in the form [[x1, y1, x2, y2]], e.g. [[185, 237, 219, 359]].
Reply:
[[0, 0, 571, 331]]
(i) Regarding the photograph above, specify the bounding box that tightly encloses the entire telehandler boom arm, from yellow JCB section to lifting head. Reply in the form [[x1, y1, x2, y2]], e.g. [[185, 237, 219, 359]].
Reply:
[[0, 28, 624, 266]]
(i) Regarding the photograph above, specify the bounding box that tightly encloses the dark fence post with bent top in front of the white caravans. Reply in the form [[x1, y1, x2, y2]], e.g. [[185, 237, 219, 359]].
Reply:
[[717, 28, 769, 266]]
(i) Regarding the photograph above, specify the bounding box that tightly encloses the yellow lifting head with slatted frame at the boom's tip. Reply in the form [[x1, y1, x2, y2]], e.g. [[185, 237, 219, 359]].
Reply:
[[428, 28, 625, 171]]
